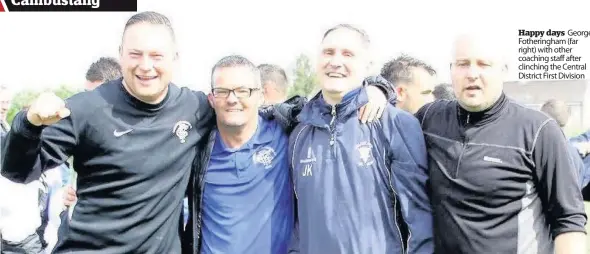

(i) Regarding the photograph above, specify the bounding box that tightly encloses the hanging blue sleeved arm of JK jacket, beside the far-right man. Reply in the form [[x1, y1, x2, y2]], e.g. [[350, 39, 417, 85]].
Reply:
[[383, 108, 434, 253]]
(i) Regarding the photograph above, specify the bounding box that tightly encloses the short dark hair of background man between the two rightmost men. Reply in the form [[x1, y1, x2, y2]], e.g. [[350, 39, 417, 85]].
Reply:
[[381, 54, 436, 86]]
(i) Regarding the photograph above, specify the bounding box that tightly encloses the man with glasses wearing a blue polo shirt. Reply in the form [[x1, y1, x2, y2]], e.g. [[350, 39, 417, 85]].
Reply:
[[186, 56, 387, 254]]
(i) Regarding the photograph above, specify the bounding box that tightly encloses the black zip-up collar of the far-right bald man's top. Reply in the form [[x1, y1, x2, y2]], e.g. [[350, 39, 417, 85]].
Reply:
[[456, 92, 508, 126]]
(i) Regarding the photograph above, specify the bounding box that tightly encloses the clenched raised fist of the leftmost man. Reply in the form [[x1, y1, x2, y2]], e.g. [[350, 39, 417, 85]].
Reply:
[[27, 92, 70, 126]]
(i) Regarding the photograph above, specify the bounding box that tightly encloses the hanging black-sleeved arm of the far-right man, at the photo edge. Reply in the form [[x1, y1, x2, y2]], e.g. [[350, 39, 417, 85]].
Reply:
[[533, 120, 586, 254]]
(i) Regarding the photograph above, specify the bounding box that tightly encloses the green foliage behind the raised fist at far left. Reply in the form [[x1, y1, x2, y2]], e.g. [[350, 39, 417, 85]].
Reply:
[[6, 85, 80, 124]]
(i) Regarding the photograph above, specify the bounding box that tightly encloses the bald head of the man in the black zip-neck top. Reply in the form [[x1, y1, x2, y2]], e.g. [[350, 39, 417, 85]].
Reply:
[[451, 32, 507, 112]]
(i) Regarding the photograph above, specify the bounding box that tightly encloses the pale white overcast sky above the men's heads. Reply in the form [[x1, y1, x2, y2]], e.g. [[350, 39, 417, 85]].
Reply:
[[0, 0, 590, 93]]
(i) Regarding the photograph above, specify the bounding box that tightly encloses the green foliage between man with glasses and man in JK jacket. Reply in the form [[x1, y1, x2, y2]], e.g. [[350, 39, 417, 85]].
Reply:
[[288, 54, 318, 98]]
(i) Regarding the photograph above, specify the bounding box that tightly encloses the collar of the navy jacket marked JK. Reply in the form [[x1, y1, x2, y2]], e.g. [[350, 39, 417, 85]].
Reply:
[[299, 86, 369, 127]]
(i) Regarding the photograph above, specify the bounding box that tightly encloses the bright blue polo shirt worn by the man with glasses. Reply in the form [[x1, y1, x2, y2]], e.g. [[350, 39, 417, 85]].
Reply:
[[201, 117, 294, 254]]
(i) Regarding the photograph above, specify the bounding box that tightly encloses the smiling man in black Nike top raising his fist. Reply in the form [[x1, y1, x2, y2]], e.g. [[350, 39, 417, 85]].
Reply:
[[2, 12, 215, 254]]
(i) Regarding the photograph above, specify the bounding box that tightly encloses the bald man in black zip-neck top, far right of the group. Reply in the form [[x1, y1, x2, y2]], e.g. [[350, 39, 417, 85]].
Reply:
[[416, 32, 586, 254]]
